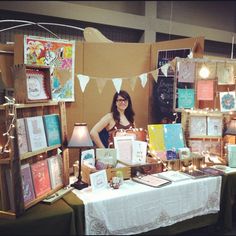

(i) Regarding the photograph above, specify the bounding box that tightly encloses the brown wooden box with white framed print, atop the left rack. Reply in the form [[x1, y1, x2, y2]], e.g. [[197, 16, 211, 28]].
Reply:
[[11, 64, 52, 103]]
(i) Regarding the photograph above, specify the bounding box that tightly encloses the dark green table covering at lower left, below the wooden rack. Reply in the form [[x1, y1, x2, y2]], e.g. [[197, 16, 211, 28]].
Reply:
[[0, 199, 76, 235]]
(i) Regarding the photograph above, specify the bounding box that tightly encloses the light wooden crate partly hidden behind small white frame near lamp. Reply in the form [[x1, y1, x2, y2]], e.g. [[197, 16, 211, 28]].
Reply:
[[81, 164, 131, 185]]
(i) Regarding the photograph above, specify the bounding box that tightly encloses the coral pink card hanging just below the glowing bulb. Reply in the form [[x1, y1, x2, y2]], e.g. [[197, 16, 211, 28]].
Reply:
[[197, 80, 214, 101]]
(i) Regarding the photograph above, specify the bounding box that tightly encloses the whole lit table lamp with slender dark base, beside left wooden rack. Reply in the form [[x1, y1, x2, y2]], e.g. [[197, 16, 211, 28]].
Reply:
[[68, 123, 93, 190]]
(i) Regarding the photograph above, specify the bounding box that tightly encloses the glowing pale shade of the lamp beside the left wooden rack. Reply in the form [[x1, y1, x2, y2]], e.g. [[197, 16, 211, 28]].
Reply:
[[68, 123, 93, 148]]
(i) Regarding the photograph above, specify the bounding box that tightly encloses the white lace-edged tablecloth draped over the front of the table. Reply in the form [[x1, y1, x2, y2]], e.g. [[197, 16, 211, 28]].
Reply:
[[73, 176, 221, 235]]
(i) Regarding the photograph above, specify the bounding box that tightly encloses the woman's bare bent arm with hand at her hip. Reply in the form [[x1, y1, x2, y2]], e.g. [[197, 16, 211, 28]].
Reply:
[[90, 113, 113, 148]]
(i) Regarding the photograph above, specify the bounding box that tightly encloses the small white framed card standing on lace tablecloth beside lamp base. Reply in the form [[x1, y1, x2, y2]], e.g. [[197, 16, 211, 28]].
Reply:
[[89, 170, 108, 191]]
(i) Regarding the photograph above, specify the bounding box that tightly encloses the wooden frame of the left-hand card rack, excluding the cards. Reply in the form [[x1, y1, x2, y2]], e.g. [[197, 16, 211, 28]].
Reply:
[[0, 101, 69, 218]]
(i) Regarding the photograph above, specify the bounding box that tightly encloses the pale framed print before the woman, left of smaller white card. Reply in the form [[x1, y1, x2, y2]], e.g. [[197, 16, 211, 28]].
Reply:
[[114, 136, 134, 164]]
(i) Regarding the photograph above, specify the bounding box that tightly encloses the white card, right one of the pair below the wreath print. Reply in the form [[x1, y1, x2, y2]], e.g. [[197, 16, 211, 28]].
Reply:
[[207, 116, 223, 136]]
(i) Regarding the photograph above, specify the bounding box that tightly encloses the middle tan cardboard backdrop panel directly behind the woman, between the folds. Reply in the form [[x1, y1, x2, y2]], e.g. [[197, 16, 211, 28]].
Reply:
[[76, 43, 150, 129]]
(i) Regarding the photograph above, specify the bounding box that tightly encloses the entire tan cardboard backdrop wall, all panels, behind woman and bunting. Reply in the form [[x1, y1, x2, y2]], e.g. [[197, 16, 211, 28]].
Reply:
[[14, 35, 204, 167]]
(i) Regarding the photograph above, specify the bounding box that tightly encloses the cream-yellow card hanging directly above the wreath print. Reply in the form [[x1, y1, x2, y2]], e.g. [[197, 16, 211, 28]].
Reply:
[[217, 62, 235, 85]]
